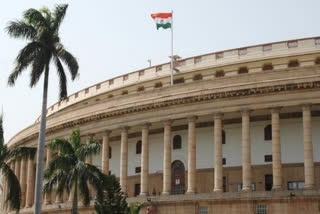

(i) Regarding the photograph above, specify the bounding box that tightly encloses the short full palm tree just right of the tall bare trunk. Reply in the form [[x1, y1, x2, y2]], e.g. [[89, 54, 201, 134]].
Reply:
[[44, 129, 104, 214]]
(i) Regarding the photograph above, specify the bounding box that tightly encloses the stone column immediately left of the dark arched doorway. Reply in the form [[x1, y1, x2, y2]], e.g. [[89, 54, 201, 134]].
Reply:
[[162, 120, 172, 195]]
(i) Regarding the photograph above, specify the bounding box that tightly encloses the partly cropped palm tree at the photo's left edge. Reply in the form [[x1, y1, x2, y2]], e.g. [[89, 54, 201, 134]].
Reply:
[[0, 115, 36, 211]]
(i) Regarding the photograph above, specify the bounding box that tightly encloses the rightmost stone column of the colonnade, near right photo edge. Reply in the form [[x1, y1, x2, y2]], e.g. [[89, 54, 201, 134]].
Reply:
[[302, 105, 315, 189]]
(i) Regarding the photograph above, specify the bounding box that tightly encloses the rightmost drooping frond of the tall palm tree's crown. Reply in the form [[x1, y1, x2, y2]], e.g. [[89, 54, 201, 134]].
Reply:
[[56, 44, 79, 80]]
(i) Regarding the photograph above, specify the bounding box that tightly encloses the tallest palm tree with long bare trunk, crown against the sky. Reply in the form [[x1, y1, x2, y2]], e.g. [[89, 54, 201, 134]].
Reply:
[[6, 5, 79, 214]]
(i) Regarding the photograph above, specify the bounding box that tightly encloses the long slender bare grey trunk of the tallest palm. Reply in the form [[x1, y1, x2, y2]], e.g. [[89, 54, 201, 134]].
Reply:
[[34, 64, 49, 214]]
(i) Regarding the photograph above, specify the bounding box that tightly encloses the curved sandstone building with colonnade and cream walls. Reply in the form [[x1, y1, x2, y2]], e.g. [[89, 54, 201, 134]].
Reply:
[[1, 38, 320, 214]]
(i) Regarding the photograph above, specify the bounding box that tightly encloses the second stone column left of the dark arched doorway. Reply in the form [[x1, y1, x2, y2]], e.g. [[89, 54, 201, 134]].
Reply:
[[140, 123, 150, 196]]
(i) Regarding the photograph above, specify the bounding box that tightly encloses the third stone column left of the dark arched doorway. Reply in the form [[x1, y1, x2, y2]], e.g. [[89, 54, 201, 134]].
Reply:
[[120, 126, 128, 194]]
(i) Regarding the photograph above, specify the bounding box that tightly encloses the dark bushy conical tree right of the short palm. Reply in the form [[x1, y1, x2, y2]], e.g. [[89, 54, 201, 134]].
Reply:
[[94, 175, 128, 214]]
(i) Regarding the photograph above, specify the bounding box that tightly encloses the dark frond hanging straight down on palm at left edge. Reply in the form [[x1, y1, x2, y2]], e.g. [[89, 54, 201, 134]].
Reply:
[[0, 162, 21, 211]]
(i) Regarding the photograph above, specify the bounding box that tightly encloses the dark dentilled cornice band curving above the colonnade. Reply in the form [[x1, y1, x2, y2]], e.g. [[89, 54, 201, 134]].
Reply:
[[8, 81, 320, 148]]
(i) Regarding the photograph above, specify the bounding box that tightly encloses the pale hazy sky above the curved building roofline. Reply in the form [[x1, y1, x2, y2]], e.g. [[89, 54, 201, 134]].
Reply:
[[0, 0, 320, 142]]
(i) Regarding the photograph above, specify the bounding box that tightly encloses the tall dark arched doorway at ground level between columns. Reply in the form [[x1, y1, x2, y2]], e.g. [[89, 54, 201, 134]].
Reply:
[[171, 160, 185, 195]]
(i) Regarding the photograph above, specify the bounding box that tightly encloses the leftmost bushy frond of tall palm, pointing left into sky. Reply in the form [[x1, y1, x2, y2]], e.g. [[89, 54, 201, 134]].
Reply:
[[5, 21, 37, 40]]
